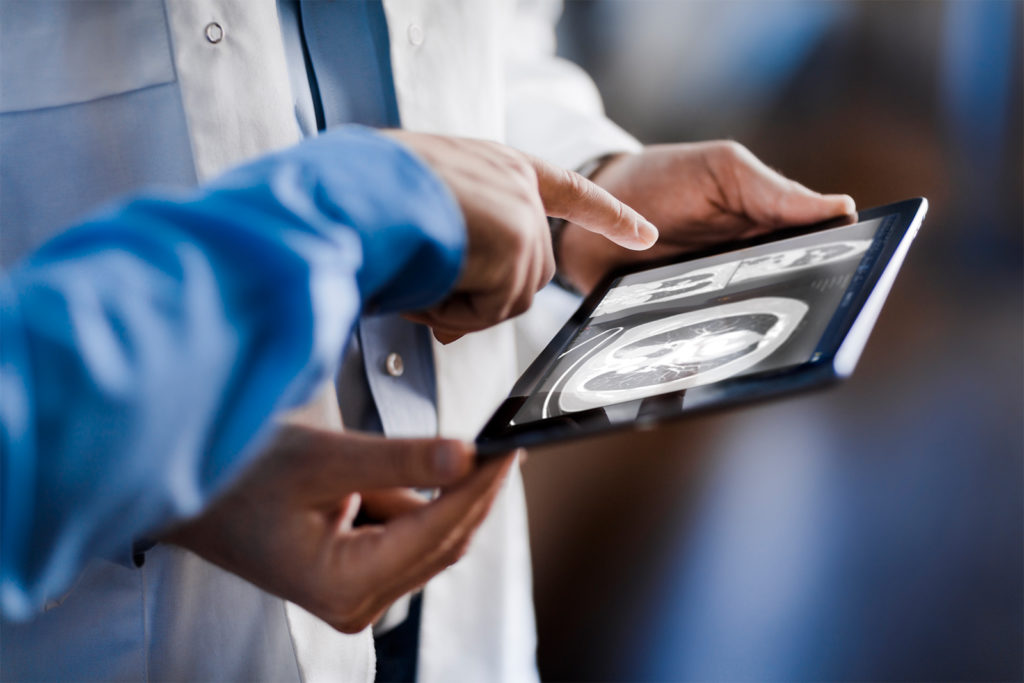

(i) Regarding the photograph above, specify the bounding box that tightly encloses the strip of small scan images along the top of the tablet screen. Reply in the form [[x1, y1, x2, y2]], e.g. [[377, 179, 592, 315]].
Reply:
[[593, 240, 871, 316]]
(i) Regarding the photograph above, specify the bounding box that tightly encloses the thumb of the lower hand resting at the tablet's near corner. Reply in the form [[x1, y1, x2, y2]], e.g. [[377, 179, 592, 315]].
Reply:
[[278, 426, 474, 499]]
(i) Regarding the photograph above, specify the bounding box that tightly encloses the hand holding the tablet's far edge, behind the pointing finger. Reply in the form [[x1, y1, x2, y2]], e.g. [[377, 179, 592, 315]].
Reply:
[[558, 141, 856, 293]]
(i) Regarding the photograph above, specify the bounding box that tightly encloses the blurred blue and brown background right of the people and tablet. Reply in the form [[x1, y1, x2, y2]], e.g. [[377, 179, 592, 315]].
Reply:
[[524, 0, 1024, 681]]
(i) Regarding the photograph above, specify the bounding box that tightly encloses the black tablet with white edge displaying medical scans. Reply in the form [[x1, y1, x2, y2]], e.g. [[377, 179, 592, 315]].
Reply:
[[476, 194, 928, 457]]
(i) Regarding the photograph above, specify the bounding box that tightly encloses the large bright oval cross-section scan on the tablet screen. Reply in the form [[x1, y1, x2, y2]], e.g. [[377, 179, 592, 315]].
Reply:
[[556, 297, 808, 413]]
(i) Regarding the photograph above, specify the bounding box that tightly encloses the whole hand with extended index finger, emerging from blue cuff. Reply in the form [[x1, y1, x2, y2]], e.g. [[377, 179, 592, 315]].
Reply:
[[387, 131, 657, 342]]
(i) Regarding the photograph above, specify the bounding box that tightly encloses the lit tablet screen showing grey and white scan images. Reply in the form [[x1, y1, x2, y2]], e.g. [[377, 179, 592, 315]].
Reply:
[[509, 217, 887, 425]]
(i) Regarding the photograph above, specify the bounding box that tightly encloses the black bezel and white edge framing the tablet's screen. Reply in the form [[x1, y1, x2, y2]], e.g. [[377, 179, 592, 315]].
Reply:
[[476, 198, 928, 458]]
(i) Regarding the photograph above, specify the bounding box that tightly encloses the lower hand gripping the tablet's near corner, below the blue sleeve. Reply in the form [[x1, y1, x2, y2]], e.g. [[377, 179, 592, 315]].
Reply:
[[164, 424, 515, 633]]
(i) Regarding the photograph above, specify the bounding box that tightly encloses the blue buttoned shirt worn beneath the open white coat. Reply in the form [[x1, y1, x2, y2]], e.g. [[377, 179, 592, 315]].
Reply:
[[278, 0, 437, 436]]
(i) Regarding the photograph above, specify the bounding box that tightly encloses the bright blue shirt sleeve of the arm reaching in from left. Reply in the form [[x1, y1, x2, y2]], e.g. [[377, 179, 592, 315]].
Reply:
[[0, 128, 466, 618]]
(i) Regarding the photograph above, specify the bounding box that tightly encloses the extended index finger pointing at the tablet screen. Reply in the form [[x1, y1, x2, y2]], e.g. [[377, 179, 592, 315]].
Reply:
[[526, 155, 657, 251]]
